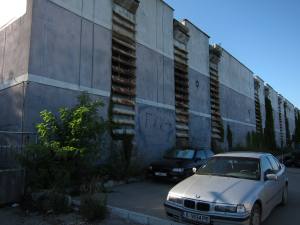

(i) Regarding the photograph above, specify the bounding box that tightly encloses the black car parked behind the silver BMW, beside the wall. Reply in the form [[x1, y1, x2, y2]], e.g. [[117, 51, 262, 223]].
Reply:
[[147, 149, 214, 181]]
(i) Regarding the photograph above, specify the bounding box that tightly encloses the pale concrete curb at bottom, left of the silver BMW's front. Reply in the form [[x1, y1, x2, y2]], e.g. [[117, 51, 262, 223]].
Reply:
[[107, 206, 183, 225]]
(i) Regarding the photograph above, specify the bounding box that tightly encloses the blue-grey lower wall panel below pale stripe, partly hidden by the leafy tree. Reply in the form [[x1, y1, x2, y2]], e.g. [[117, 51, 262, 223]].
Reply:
[[24, 82, 109, 131]]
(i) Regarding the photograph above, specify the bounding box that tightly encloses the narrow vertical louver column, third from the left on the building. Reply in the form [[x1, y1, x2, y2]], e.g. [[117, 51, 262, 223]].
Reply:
[[209, 45, 223, 141]]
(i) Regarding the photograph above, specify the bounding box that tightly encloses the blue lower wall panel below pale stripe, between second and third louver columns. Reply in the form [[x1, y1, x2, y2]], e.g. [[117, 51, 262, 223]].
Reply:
[[189, 114, 211, 149]]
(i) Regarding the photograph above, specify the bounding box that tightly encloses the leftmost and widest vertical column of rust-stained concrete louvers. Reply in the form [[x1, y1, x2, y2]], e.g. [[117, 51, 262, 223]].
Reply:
[[111, 0, 139, 137]]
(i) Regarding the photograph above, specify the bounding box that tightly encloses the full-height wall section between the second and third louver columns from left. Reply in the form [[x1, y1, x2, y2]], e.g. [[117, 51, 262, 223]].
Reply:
[[183, 20, 211, 148]]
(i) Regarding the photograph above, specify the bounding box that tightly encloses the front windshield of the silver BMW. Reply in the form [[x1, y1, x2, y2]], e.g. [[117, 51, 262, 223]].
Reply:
[[197, 156, 260, 180]]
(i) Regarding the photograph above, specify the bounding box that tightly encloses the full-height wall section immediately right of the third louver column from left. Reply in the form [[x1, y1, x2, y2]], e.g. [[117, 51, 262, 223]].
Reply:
[[219, 50, 256, 146]]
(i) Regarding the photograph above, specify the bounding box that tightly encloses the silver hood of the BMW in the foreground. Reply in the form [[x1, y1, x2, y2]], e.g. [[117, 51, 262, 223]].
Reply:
[[170, 175, 261, 204]]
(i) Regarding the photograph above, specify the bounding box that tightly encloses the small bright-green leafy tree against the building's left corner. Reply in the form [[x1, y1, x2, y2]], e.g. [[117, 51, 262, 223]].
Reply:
[[20, 94, 108, 190]]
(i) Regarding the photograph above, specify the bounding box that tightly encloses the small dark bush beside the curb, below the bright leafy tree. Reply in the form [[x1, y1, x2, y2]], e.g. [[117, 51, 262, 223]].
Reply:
[[80, 194, 107, 221]]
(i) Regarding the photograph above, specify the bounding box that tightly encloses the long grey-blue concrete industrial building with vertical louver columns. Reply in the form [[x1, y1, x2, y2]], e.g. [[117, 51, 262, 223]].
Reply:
[[0, 0, 295, 160]]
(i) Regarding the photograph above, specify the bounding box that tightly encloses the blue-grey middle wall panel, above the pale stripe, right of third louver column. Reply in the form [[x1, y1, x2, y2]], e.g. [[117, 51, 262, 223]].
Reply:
[[220, 85, 255, 126]]
